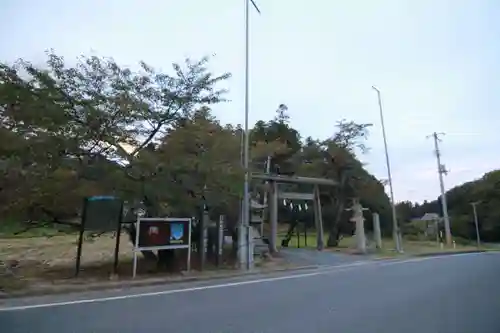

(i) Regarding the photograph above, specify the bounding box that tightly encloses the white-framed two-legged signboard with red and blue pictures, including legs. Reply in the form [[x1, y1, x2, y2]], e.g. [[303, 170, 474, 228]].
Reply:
[[132, 217, 191, 278]]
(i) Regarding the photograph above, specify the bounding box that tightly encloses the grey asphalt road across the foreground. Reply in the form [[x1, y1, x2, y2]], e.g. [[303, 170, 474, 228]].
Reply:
[[0, 253, 500, 333]]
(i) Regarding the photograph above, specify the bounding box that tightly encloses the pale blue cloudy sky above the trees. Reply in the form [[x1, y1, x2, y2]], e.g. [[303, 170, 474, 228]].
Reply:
[[0, 0, 500, 201]]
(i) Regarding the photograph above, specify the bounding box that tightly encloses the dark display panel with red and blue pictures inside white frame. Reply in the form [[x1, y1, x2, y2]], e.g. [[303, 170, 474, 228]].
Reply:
[[137, 218, 190, 248]]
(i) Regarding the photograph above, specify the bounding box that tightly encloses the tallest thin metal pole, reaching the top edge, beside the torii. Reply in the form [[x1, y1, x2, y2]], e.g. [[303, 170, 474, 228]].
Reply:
[[242, 0, 251, 269]]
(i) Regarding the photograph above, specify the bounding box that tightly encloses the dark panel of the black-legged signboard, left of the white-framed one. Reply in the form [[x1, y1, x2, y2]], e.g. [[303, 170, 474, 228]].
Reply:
[[82, 196, 123, 231]]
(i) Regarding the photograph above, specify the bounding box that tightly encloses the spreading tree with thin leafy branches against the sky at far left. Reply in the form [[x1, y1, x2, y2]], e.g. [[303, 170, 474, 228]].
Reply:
[[0, 53, 229, 220]]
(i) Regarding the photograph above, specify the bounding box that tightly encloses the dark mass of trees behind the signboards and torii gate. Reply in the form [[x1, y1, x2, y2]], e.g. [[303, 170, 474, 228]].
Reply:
[[0, 53, 391, 246]]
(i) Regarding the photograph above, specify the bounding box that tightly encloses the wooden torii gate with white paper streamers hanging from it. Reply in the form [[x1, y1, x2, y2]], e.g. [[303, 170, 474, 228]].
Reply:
[[251, 173, 338, 252]]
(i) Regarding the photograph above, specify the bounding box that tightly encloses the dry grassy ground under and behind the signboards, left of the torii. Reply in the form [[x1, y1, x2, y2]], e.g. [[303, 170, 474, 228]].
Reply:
[[0, 234, 241, 290]]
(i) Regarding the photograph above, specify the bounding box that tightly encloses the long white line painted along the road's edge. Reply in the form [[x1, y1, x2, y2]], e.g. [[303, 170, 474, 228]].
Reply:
[[0, 253, 480, 312]]
